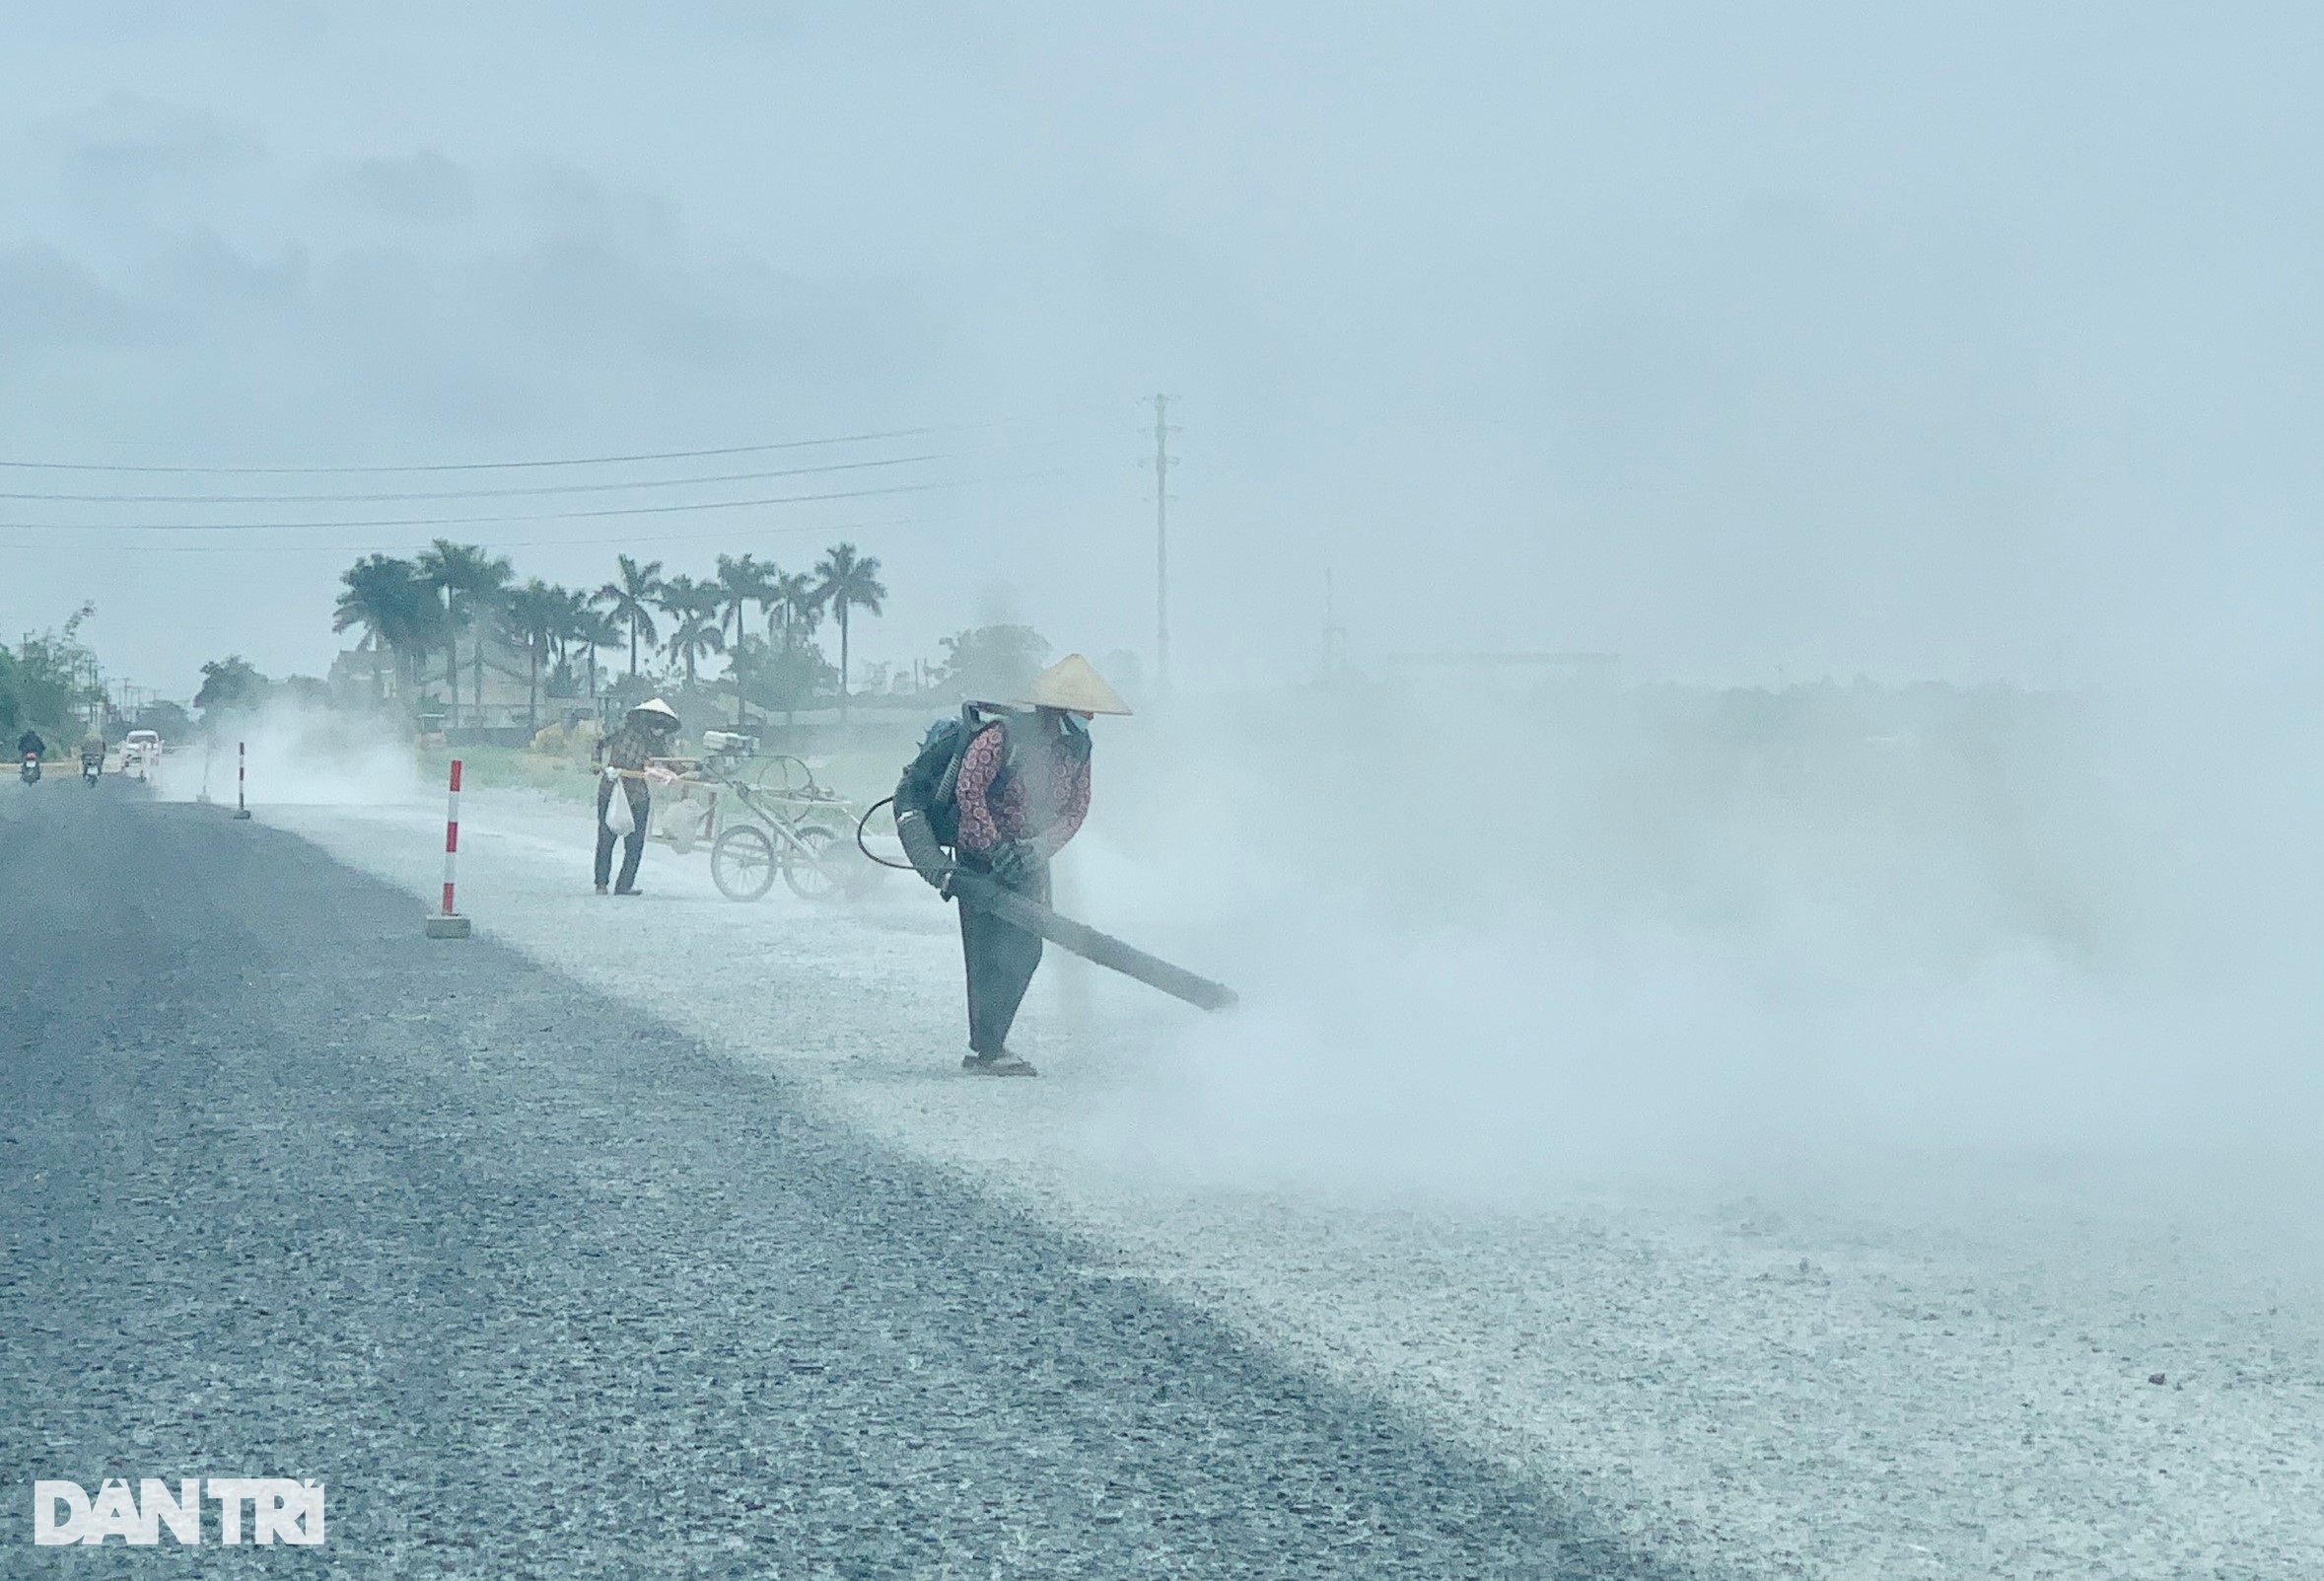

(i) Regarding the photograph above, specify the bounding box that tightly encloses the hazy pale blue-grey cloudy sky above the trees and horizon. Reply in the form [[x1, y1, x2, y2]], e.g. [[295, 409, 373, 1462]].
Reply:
[[0, 2, 2324, 695]]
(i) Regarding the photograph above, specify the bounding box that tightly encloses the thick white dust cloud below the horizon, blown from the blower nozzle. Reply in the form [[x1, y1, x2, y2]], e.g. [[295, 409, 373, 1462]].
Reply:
[[1081, 683, 2324, 1197]]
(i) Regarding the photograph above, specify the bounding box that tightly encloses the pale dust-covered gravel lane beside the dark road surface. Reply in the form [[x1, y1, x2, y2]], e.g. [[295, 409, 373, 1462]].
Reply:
[[245, 786, 2324, 1581]]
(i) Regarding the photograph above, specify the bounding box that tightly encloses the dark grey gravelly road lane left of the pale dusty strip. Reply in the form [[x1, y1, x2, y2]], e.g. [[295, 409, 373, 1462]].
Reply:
[[0, 783, 1692, 1579]]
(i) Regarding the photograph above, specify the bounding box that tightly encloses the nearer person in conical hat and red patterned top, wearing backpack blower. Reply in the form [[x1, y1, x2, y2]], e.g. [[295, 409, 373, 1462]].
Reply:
[[894, 653, 1130, 1076]]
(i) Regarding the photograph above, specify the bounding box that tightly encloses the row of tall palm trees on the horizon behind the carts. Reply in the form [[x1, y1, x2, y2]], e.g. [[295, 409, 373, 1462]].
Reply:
[[330, 538, 887, 725]]
